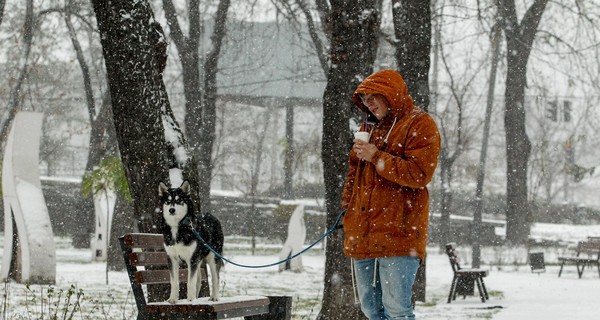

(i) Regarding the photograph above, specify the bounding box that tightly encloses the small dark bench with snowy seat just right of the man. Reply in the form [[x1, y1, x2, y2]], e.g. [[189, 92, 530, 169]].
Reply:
[[446, 243, 490, 303]]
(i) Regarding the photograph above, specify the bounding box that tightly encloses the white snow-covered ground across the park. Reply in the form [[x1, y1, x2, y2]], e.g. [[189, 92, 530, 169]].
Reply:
[[0, 225, 600, 320]]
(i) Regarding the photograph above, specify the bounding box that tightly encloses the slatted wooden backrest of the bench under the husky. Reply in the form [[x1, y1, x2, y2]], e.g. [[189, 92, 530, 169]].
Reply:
[[119, 233, 208, 310]]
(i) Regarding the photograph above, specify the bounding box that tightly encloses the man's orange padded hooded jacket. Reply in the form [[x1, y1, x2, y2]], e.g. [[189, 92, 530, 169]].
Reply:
[[342, 70, 440, 261]]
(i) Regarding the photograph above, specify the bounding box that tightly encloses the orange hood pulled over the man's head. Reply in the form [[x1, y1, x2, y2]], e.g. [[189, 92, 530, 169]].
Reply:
[[352, 70, 414, 116]]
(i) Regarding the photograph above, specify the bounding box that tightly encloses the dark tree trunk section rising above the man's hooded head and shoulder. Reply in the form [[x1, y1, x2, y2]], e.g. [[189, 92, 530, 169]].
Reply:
[[392, 0, 431, 111]]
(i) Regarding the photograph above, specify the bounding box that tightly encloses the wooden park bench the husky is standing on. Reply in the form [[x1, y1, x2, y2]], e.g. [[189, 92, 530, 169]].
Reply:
[[119, 233, 292, 320]]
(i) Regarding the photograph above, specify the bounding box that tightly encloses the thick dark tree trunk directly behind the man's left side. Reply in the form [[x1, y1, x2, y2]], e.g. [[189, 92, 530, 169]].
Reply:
[[318, 0, 380, 320]]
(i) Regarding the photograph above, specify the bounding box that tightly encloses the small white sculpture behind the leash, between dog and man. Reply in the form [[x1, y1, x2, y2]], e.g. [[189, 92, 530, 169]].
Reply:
[[279, 205, 306, 272]]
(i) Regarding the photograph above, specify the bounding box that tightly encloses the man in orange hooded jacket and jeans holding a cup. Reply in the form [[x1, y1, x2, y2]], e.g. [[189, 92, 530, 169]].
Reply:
[[342, 70, 440, 320]]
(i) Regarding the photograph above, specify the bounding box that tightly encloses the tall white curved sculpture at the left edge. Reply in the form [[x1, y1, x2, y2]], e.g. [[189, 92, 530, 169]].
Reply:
[[0, 112, 56, 284]]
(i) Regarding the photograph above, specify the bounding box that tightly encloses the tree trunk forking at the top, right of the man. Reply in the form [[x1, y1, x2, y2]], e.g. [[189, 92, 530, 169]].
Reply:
[[499, 0, 548, 245]]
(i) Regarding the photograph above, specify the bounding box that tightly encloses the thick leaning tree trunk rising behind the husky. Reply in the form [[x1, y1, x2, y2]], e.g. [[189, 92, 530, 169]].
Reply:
[[92, 0, 188, 233]]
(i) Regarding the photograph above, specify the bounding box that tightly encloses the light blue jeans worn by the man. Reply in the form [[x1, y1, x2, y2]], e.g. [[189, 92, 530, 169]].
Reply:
[[354, 256, 419, 320]]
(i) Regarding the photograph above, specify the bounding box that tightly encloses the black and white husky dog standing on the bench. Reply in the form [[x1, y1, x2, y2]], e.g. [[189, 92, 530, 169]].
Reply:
[[158, 180, 223, 304]]
